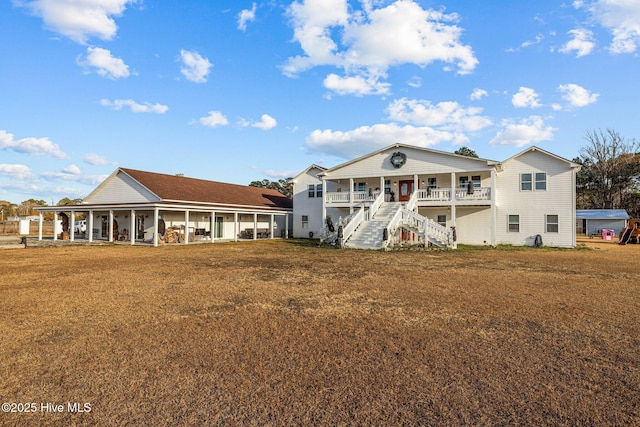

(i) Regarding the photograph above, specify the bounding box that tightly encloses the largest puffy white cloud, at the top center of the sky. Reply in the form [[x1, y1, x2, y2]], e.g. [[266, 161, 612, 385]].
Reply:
[[282, 0, 478, 95]]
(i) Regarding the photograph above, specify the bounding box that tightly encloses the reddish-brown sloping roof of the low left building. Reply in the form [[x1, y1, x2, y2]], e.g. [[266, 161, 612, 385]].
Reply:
[[118, 168, 293, 209]]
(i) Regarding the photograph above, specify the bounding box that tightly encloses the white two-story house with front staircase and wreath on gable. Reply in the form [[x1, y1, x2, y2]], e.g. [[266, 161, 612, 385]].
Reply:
[[293, 144, 580, 249]]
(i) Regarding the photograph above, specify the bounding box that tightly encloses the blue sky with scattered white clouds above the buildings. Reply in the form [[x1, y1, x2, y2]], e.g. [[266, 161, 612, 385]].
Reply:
[[0, 0, 640, 204]]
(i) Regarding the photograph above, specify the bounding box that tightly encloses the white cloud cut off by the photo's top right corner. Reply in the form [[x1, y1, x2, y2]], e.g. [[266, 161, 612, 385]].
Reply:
[[574, 0, 640, 53]]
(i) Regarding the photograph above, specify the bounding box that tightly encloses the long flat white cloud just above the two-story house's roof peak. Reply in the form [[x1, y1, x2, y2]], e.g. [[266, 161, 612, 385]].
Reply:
[[305, 124, 468, 159]]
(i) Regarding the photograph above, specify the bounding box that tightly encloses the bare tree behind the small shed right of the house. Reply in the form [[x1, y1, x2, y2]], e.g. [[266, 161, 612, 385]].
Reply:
[[575, 129, 640, 215]]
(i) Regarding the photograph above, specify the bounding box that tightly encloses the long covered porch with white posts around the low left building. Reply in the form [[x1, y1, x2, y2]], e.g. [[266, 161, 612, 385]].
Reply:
[[38, 204, 290, 246]]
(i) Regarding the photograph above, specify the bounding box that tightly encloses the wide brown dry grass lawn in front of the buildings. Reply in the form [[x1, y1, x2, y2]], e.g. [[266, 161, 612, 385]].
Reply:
[[0, 240, 640, 426]]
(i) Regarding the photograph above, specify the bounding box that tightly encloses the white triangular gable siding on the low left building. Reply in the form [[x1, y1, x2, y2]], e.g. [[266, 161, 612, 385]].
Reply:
[[84, 172, 160, 204]]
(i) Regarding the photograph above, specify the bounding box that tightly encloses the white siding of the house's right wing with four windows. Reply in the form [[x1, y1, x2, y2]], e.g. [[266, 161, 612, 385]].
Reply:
[[496, 150, 575, 247]]
